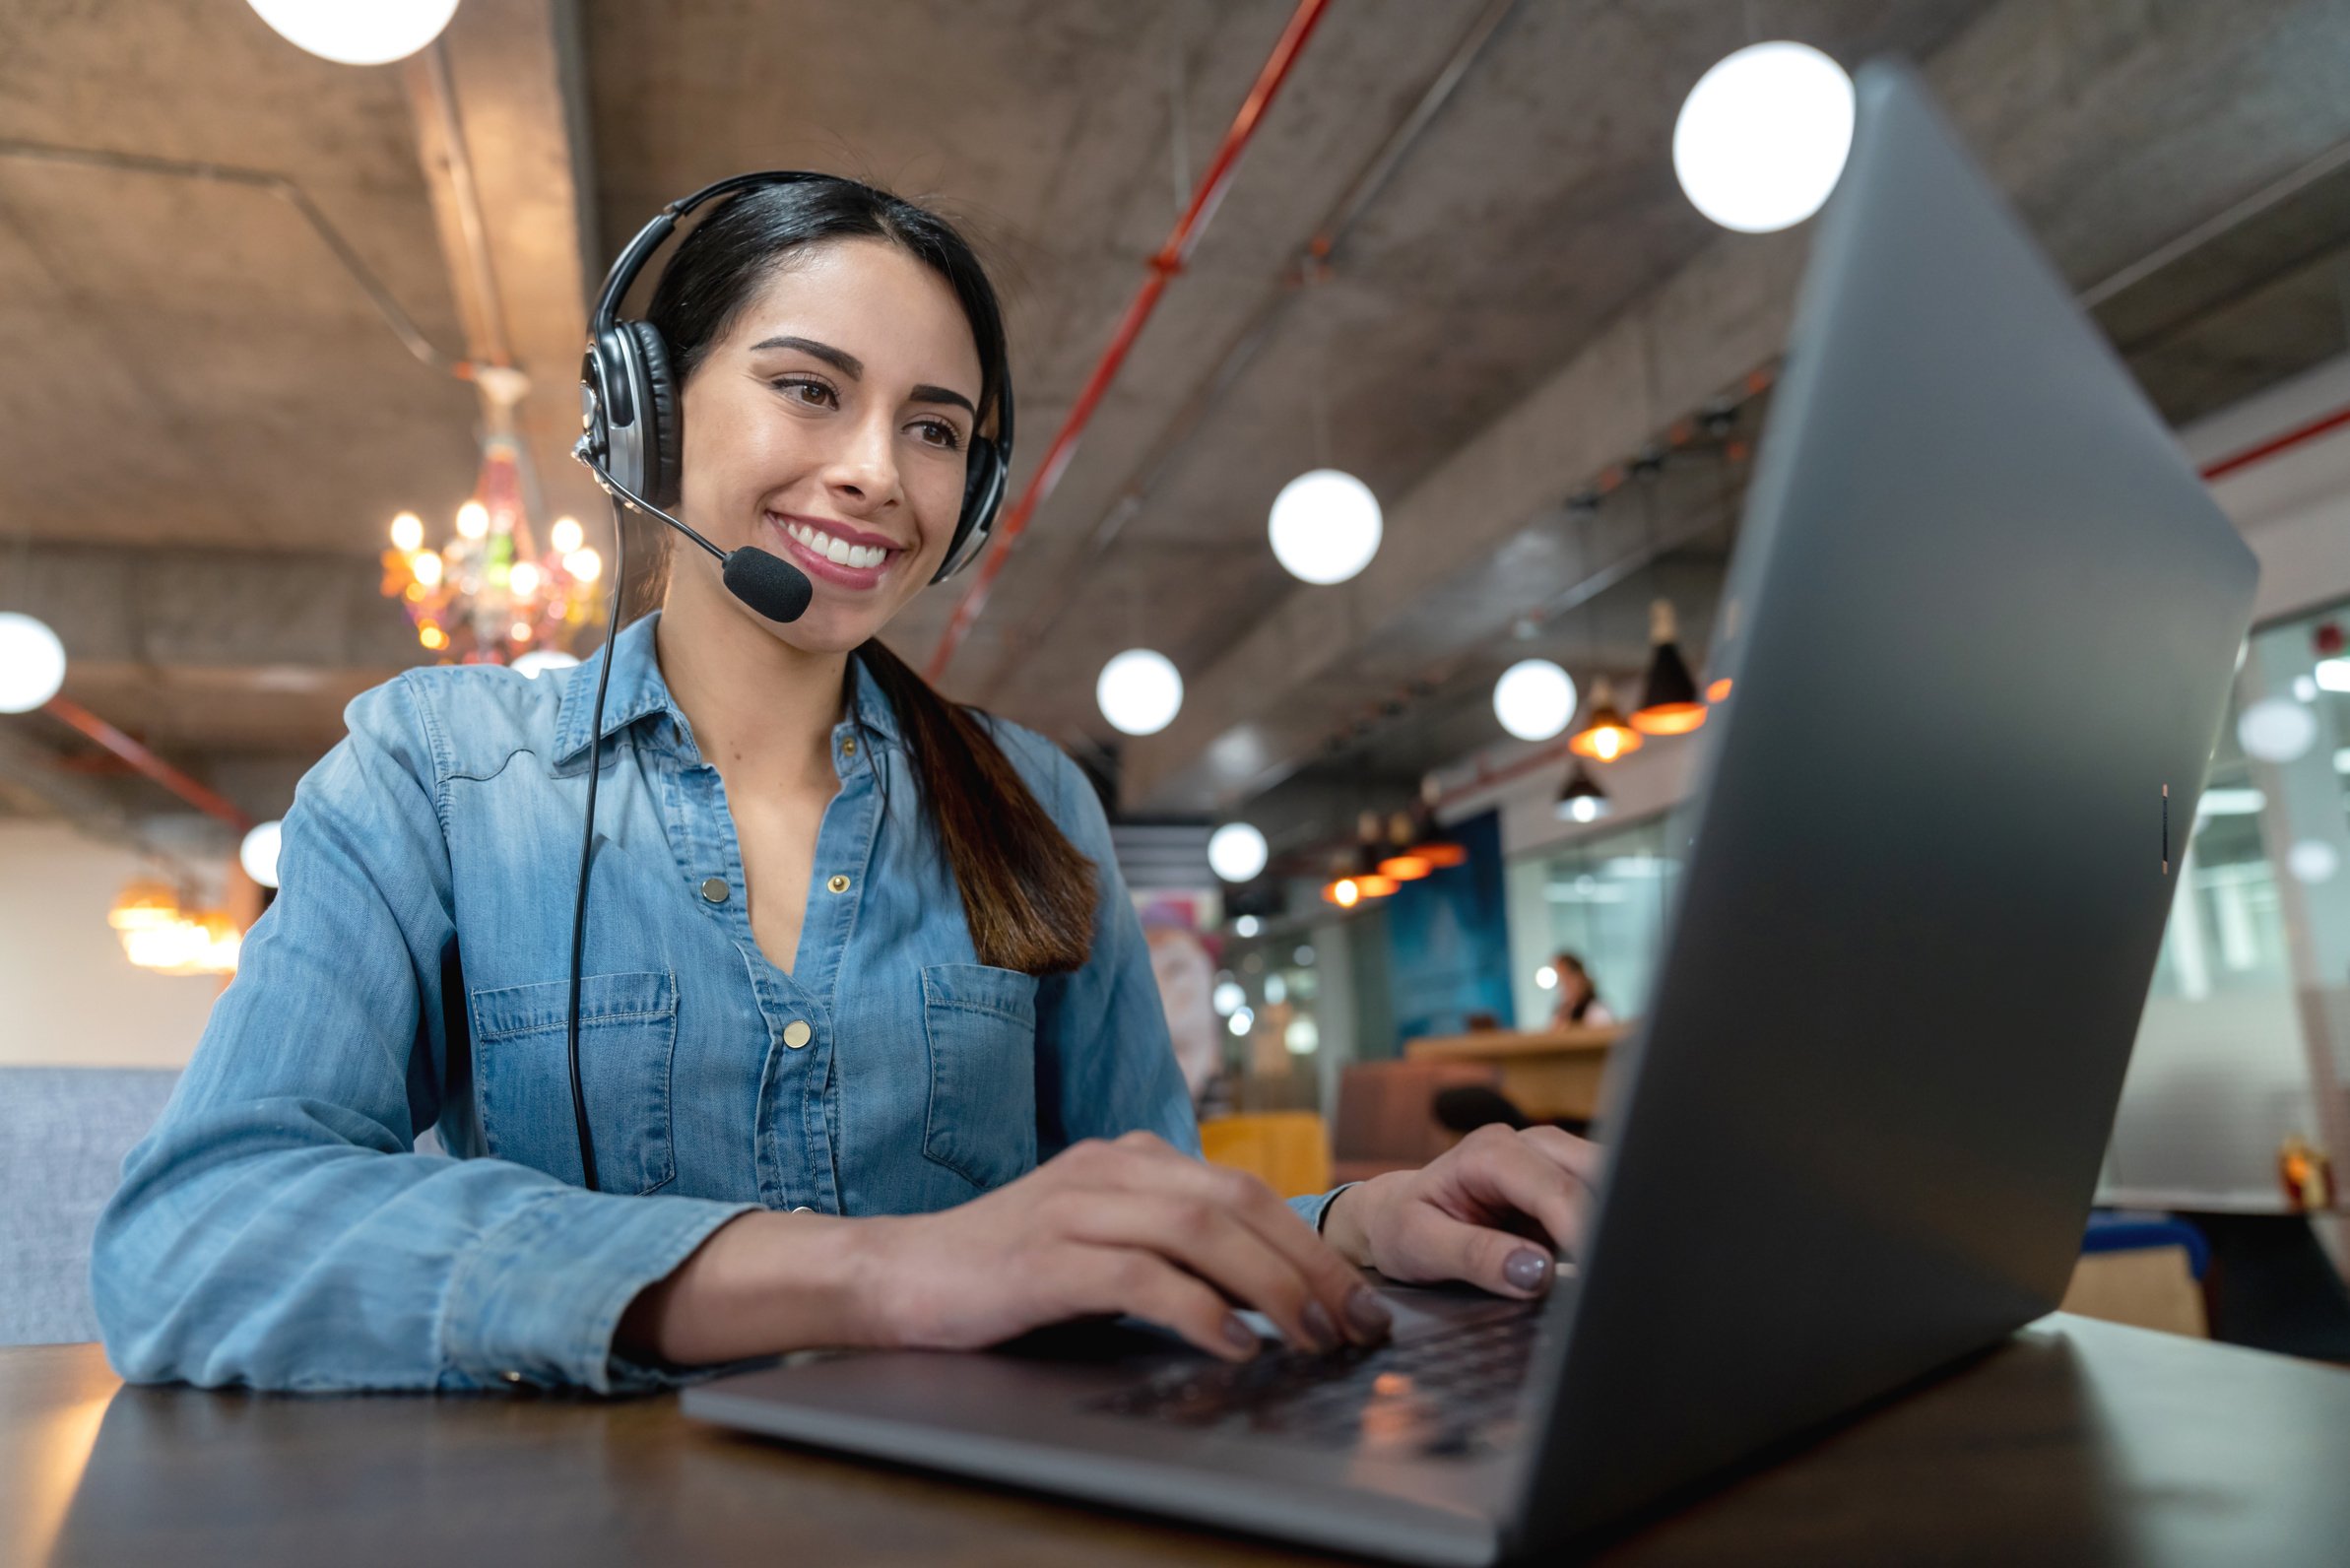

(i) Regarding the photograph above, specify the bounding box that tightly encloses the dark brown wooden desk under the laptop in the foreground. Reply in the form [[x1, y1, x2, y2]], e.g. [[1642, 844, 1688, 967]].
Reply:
[[14, 1317, 2350, 1568]]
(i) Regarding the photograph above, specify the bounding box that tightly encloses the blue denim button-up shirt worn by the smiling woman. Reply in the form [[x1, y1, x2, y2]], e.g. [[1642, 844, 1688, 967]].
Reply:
[[92, 616, 1326, 1392]]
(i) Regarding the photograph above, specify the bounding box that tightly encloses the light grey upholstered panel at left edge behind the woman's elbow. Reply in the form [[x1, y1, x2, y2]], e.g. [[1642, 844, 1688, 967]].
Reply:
[[0, 1068, 178, 1344]]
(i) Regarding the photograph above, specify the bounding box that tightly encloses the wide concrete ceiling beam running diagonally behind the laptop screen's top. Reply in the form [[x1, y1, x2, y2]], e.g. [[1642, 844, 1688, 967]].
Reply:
[[1124, 0, 2350, 811]]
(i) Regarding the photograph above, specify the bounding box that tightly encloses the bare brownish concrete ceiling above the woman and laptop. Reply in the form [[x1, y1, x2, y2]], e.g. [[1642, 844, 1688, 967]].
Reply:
[[0, 0, 2350, 860]]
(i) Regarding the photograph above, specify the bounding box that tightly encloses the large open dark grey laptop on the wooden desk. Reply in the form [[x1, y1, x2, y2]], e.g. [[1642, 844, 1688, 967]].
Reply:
[[684, 66, 2256, 1563]]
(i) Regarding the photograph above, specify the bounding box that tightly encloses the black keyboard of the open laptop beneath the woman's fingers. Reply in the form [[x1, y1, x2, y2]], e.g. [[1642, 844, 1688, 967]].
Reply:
[[1085, 1312, 1541, 1458]]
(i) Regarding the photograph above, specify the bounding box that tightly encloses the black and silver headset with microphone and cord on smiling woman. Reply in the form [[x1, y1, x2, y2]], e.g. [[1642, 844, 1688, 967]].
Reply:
[[564, 169, 1012, 1192]]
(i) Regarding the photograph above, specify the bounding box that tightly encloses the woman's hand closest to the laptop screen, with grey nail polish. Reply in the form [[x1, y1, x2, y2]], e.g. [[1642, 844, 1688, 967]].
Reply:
[[1323, 1124, 1600, 1298]]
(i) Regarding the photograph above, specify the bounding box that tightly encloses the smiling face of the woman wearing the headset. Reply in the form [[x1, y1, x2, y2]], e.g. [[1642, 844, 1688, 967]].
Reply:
[[668, 239, 980, 654]]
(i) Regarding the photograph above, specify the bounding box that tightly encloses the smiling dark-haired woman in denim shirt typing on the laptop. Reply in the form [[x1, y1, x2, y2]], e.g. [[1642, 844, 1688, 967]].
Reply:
[[94, 181, 1594, 1392]]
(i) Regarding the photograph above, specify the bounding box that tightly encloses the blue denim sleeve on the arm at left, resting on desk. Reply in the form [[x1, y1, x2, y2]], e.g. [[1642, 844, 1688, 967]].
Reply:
[[92, 677, 750, 1392]]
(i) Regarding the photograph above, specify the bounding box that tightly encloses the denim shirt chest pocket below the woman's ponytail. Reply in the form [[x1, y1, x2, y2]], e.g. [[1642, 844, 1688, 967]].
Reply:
[[921, 964, 1036, 1190]]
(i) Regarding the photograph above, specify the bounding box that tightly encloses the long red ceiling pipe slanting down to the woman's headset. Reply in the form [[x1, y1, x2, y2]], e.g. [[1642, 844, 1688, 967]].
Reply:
[[924, 0, 1330, 682]]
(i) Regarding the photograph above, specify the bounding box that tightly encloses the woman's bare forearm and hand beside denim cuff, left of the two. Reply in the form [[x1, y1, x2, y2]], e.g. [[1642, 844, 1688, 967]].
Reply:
[[616, 1133, 1389, 1366]]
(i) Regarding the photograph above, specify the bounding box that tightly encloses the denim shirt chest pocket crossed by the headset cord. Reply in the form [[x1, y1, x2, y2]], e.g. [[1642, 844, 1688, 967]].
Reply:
[[470, 973, 677, 1194]]
